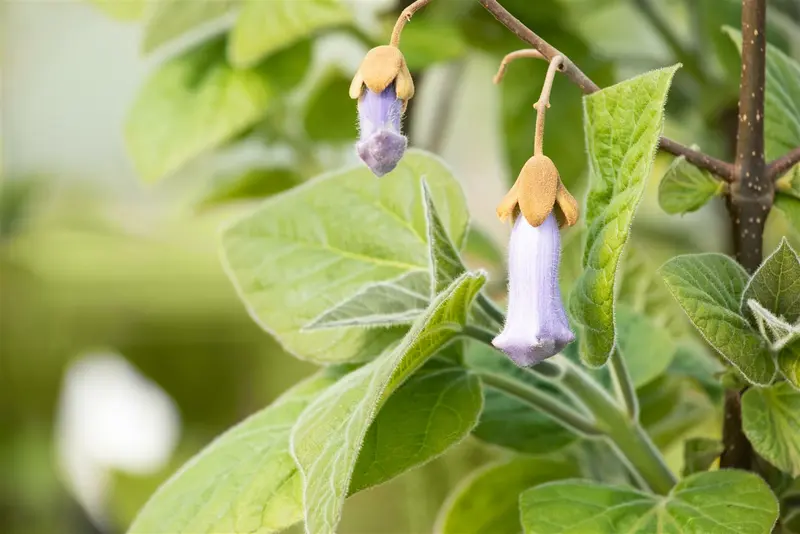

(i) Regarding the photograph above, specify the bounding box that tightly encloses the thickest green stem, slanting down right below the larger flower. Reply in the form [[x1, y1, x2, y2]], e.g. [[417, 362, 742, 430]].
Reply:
[[561, 359, 677, 495]]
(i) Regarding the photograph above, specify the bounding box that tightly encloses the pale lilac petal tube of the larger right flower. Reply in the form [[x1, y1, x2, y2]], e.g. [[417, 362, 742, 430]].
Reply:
[[492, 213, 575, 367]]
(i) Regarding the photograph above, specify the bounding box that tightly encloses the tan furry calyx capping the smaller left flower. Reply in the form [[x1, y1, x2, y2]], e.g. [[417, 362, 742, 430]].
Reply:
[[350, 45, 414, 101]]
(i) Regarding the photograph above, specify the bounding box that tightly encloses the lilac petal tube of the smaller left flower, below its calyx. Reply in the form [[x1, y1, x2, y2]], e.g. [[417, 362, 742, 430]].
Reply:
[[356, 82, 408, 177]]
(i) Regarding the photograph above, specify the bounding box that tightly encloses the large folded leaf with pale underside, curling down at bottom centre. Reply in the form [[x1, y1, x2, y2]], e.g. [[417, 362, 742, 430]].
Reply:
[[291, 272, 485, 534]]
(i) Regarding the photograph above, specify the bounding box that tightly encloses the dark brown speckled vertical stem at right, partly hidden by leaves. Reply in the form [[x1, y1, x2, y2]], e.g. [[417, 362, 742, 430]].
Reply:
[[720, 0, 775, 470]]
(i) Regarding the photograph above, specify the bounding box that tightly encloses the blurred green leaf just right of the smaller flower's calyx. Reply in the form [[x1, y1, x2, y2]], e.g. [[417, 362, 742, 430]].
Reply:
[[396, 17, 468, 71]]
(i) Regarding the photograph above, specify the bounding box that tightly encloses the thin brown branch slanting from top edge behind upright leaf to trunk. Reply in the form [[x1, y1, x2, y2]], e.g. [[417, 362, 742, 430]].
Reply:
[[478, 0, 733, 182]]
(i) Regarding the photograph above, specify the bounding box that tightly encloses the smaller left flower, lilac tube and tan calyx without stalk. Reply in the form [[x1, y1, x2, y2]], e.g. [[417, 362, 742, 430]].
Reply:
[[350, 46, 414, 176]]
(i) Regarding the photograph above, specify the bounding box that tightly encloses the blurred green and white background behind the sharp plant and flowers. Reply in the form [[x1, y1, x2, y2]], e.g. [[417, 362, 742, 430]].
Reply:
[[0, 0, 800, 534]]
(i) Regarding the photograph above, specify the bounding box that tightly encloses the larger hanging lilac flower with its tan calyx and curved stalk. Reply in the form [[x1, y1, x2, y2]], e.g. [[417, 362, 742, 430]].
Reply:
[[492, 52, 578, 367]]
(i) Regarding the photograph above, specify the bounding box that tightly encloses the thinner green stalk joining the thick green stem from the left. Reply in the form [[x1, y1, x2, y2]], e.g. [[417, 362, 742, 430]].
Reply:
[[476, 371, 600, 436]]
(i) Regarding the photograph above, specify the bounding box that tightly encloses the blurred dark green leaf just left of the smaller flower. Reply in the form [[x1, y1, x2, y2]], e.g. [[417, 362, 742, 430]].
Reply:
[[303, 69, 358, 143]]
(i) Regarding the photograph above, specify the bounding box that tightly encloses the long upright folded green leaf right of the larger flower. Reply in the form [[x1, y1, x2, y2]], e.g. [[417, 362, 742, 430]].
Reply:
[[570, 66, 678, 367]]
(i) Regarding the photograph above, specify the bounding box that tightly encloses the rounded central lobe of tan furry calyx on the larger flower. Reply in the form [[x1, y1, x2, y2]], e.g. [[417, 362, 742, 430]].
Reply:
[[517, 155, 561, 227]]
